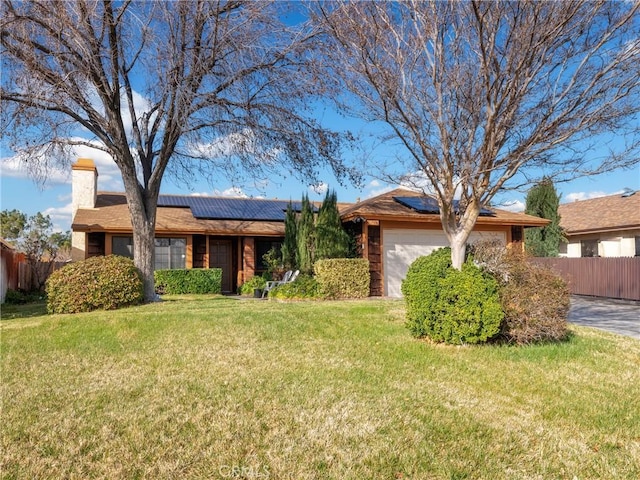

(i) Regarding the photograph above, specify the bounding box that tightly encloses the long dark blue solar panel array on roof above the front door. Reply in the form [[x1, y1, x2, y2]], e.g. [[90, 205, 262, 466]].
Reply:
[[158, 195, 310, 221]]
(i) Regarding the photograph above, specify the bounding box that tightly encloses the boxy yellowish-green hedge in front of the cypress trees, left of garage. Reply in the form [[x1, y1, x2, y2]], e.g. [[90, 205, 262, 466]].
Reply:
[[314, 258, 370, 298]]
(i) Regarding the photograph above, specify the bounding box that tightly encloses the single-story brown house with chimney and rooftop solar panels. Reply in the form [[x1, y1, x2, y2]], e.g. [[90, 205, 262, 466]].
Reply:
[[71, 159, 548, 297]]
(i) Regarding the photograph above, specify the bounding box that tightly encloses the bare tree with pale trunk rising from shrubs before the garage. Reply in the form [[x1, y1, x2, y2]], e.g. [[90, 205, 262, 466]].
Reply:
[[310, 0, 640, 268]]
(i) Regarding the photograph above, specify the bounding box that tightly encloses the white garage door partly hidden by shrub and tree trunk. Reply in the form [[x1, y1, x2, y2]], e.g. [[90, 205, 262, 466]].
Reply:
[[382, 229, 507, 297]]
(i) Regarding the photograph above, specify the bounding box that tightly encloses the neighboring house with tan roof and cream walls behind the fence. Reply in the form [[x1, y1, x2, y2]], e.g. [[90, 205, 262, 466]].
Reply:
[[558, 192, 640, 257]]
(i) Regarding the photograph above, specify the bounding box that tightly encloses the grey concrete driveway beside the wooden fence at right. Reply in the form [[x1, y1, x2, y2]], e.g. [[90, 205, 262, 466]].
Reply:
[[568, 295, 640, 339]]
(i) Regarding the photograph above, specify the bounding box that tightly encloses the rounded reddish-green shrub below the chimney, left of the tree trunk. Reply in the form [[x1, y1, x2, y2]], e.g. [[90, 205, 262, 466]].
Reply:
[[46, 255, 144, 313]]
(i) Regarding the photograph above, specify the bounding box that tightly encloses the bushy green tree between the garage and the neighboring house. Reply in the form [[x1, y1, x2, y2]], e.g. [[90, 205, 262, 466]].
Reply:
[[525, 177, 564, 257]]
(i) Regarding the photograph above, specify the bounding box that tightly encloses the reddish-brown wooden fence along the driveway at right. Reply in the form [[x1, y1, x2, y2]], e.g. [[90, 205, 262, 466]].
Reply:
[[532, 257, 640, 301]]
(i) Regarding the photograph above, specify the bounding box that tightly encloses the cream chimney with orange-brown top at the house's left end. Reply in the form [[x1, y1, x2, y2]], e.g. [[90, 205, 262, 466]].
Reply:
[[71, 158, 98, 261]]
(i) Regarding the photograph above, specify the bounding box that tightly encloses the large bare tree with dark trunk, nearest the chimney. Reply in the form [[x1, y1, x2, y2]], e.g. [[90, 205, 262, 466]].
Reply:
[[0, 0, 356, 300]]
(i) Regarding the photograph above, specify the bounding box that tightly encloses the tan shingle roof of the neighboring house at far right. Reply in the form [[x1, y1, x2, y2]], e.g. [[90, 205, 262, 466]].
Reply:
[[558, 192, 640, 234]]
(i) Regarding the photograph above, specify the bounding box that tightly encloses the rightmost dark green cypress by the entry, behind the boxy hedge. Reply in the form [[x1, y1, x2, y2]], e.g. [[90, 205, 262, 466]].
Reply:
[[315, 190, 349, 260]]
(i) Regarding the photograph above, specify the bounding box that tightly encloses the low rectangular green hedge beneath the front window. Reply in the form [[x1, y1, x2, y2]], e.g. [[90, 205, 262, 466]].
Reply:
[[153, 268, 222, 295]]
